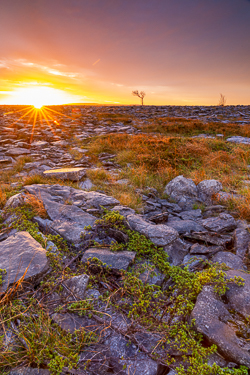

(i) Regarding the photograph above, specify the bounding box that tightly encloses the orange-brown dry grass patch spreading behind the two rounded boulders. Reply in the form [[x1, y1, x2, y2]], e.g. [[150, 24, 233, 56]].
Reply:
[[85, 134, 250, 217]]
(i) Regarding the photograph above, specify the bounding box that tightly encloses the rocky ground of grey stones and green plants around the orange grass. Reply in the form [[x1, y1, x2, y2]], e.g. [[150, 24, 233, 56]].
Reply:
[[0, 106, 250, 375]]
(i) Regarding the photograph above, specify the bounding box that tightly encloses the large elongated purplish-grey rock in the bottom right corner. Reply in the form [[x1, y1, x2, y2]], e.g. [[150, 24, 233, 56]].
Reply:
[[191, 286, 250, 368]]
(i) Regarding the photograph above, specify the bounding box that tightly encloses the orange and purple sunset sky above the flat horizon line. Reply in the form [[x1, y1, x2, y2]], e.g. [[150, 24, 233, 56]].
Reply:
[[0, 0, 250, 105]]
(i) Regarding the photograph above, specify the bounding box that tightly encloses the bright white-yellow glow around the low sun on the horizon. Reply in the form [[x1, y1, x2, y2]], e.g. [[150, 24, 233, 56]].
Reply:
[[1, 86, 76, 109]]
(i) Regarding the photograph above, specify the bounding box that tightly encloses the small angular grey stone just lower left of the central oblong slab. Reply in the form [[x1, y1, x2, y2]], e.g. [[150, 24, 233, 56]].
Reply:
[[62, 274, 89, 300]]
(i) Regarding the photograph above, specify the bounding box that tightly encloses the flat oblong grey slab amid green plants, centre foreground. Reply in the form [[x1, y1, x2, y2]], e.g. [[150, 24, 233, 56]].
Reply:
[[82, 247, 136, 271]]
